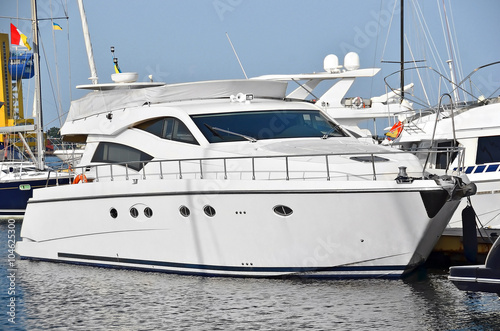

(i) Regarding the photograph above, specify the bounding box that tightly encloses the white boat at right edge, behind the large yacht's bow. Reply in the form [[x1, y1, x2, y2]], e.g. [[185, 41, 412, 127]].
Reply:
[[386, 62, 500, 264]]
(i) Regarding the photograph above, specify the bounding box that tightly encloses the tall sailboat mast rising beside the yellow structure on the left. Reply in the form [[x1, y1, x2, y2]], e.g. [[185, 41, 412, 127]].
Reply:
[[31, 0, 45, 170]]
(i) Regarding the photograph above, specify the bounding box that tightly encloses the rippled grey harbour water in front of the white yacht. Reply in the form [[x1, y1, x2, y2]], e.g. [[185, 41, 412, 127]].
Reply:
[[0, 222, 500, 330]]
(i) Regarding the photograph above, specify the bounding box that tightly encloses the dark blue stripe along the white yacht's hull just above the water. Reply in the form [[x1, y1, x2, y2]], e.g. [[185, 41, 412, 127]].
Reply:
[[58, 253, 406, 273]]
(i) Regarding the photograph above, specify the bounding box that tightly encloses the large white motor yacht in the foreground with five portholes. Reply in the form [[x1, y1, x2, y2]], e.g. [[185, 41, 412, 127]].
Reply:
[[17, 74, 474, 278]]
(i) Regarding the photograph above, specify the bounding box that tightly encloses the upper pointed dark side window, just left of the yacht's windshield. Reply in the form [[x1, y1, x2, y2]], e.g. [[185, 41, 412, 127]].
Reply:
[[136, 117, 198, 144]]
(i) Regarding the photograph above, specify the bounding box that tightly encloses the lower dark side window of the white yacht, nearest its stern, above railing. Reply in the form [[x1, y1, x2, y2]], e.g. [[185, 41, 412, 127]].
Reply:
[[92, 142, 153, 171]]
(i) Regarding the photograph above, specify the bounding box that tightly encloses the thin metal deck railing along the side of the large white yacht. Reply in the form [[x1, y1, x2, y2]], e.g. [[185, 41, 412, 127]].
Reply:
[[66, 147, 463, 182]]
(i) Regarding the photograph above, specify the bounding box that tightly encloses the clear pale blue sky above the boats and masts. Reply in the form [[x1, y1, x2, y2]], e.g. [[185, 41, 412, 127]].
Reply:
[[0, 0, 500, 128]]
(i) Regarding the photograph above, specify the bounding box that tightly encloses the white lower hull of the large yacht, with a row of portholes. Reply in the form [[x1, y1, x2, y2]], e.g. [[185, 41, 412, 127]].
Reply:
[[17, 179, 459, 278]]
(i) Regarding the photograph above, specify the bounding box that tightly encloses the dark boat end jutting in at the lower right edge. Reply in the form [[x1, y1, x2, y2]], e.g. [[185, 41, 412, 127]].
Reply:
[[448, 236, 500, 295]]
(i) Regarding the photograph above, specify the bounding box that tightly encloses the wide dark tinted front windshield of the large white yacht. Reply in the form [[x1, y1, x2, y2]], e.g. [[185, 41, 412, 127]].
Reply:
[[191, 110, 348, 143]]
